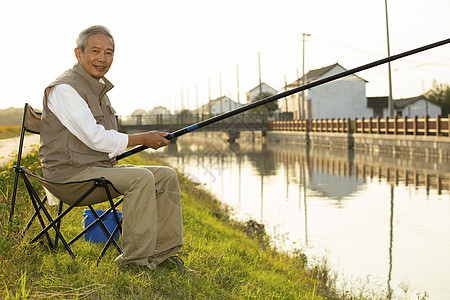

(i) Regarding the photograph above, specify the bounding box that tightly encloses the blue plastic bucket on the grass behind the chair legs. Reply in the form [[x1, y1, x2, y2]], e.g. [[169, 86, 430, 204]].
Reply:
[[83, 209, 122, 243]]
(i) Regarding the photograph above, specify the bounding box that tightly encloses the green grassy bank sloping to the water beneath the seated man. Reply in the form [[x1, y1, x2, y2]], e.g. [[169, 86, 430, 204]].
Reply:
[[0, 151, 336, 299]]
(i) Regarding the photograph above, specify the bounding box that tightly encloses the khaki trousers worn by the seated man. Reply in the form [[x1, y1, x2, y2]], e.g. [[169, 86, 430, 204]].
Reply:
[[70, 165, 183, 265]]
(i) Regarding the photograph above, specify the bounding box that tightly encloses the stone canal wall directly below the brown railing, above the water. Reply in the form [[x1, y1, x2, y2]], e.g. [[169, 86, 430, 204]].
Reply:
[[266, 131, 450, 161]]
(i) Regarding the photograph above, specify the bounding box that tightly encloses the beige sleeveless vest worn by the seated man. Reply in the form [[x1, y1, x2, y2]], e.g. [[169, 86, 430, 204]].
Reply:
[[39, 63, 117, 182]]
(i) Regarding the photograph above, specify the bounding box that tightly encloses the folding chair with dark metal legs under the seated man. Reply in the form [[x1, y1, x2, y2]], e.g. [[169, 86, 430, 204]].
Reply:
[[10, 103, 123, 263]]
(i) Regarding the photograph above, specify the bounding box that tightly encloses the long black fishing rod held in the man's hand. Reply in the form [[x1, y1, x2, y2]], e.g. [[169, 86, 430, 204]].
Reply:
[[116, 39, 450, 160]]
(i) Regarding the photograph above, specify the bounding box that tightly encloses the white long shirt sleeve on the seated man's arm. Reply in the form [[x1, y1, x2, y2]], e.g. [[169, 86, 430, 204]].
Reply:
[[47, 84, 128, 158]]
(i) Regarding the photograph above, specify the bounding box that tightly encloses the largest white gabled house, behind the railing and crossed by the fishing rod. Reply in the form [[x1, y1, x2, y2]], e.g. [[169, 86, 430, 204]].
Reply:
[[279, 63, 372, 119]]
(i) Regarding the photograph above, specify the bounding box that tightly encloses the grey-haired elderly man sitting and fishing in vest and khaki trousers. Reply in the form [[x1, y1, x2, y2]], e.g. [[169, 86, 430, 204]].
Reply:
[[39, 26, 189, 271]]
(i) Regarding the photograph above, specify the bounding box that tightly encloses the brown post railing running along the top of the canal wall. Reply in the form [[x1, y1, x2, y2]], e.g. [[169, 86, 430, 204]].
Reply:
[[267, 115, 450, 137]]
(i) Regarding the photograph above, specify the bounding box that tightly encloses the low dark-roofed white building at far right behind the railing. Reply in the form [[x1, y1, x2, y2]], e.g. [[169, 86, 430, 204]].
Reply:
[[367, 95, 442, 118]]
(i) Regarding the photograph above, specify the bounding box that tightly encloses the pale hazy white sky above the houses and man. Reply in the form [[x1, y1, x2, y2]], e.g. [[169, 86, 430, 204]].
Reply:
[[0, 0, 450, 115]]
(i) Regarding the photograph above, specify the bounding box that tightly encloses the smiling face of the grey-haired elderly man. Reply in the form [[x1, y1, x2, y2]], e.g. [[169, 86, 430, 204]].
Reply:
[[75, 33, 114, 80]]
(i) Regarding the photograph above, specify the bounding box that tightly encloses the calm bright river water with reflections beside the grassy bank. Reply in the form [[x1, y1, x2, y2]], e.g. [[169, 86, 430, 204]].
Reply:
[[158, 133, 450, 299]]
